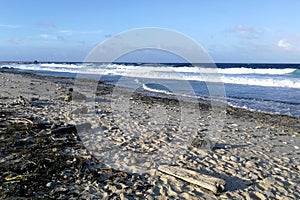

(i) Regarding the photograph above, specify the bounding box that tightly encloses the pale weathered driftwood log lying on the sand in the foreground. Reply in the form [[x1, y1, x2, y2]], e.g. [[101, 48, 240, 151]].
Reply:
[[158, 165, 226, 194]]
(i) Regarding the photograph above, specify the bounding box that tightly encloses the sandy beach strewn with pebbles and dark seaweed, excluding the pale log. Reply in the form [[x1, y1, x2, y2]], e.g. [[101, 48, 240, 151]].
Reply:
[[0, 70, 300, 199]]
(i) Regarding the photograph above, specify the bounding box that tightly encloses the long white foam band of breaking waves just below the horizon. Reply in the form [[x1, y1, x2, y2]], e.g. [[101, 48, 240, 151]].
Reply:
[[1, 63, 300, 88]]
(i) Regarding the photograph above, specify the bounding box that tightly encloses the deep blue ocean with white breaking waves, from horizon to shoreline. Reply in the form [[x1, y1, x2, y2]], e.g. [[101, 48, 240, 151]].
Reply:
[[0, 63, 300, 118]]
